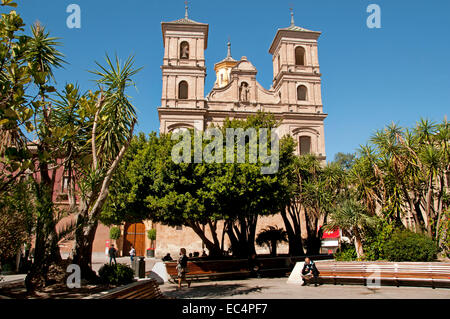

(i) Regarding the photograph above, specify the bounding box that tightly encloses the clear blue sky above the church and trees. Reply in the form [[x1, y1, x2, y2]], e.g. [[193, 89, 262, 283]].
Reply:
[[12, 0, 450, 160]]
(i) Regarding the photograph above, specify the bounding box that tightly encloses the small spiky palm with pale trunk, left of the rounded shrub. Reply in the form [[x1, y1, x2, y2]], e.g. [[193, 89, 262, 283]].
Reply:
[[324, 198, 377, 258]]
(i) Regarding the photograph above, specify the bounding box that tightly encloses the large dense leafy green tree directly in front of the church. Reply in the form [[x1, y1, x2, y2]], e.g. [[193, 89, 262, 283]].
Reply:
[[106, 113, 293, 256]]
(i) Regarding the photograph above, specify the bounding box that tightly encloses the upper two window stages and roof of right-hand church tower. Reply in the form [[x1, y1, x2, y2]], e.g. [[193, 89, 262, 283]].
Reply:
[[269, 9, 323, 113]]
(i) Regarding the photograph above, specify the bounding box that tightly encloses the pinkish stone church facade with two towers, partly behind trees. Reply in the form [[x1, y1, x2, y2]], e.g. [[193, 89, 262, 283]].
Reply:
[[149, 12, 327, 257]]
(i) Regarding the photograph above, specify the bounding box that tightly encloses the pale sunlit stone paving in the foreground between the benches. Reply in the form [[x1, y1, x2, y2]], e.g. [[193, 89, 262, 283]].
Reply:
[[159, 278, 450, 299]]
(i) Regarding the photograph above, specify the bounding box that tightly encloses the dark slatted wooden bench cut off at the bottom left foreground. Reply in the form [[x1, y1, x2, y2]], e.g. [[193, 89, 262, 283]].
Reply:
[[98, 279, 166, 299]]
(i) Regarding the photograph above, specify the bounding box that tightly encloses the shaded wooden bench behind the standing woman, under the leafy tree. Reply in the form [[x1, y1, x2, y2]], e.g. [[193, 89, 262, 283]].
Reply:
[[165, 259, 250, 282]]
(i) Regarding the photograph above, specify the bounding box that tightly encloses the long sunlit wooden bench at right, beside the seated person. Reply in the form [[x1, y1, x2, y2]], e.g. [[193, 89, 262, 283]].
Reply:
[[310, 262, 450, 288]]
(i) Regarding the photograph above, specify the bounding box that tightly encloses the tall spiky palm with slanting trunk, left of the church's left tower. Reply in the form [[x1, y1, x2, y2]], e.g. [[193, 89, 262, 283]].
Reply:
[[73, 56, 142, 279]]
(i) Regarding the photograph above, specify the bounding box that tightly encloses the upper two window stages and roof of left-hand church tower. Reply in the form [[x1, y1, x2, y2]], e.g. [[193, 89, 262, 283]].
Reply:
[[161, 5, 208, 109]]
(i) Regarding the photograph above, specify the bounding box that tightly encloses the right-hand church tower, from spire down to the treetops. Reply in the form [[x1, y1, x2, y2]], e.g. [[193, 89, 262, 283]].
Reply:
[[269, 12, 326, 160]]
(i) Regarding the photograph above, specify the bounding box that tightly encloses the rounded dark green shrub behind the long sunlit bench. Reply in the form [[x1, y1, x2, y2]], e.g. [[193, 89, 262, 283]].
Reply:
[[383, 230, 437, 261]]
